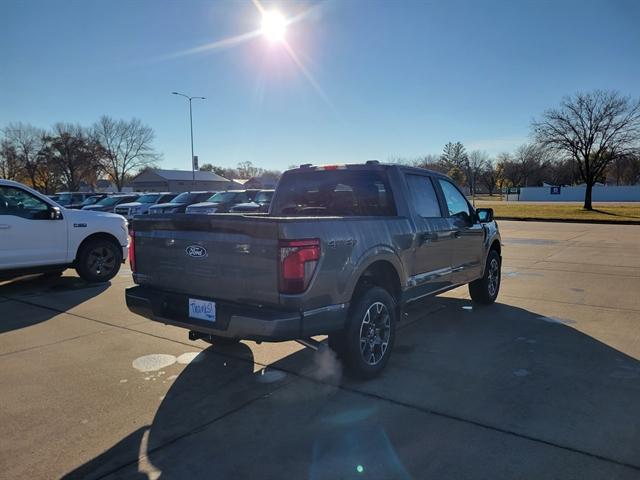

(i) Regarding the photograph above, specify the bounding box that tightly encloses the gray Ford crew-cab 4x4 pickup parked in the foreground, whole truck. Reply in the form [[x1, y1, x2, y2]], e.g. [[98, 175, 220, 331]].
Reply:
[[126, 161, 501, 378]]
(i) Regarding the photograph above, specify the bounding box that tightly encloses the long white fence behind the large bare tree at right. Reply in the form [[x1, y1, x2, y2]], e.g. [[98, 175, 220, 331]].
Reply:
[[507, 185, 640, 202]]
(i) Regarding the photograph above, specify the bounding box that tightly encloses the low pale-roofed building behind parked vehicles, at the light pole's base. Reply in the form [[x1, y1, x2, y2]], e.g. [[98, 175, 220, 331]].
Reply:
[[128, 169, 235, 192]]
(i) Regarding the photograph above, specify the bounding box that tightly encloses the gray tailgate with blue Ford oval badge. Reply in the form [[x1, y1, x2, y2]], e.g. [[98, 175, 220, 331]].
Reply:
[[133, 214, 279, 305]]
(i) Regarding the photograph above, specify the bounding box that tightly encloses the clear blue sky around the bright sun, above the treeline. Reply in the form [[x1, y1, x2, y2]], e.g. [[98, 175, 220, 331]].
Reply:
[[0, 0, 640, 169]]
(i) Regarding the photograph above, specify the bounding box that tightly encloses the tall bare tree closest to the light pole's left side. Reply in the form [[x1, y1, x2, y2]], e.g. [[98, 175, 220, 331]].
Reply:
[[93, 116, 158, 191]]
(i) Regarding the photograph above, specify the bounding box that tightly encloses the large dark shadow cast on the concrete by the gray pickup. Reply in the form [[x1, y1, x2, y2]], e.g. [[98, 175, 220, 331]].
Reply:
[[67, 298, 640, 479]]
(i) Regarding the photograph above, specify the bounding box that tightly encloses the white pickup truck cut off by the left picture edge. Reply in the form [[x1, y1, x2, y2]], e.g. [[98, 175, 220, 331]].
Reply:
[[0, 179, 129, 282]]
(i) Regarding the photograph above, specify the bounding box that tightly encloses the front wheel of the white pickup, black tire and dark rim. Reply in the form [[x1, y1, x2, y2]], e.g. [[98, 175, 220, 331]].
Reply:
[[76, 238, 122, 283]]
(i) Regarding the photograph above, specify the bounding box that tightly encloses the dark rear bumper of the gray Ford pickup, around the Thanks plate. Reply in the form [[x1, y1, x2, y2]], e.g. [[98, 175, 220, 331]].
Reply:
[[125, 286, 349, 342]]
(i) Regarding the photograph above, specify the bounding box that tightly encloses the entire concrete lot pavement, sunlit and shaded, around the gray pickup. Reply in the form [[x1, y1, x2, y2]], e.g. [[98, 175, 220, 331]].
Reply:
[[0, 221, 640, 479]]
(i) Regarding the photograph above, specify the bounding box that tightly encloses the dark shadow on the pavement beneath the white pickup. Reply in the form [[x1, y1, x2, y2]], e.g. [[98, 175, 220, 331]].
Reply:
[[0, 275, 111, 334]]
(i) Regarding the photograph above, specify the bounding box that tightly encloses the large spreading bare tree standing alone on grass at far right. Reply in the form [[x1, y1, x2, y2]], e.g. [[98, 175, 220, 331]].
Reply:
[[532, 90, 640, 210]]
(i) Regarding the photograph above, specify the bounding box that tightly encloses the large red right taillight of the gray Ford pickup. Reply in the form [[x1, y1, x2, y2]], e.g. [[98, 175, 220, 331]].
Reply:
[[278, 238, 320, 293]]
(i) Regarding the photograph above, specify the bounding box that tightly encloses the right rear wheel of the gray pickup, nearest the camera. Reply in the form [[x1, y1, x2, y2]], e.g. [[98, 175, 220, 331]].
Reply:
[[329, 286, 397, 379]]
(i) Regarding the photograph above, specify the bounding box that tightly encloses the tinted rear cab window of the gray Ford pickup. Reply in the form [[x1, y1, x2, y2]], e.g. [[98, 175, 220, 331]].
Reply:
[[271, 169, 396, 217]]
